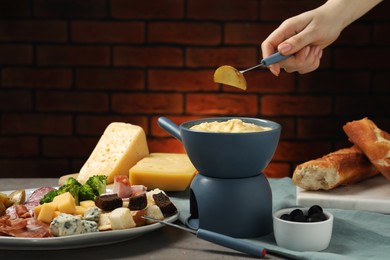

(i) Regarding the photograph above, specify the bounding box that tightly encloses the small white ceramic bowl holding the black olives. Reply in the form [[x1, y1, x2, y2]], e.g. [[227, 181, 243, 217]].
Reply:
[[273, 208, 333, 251]]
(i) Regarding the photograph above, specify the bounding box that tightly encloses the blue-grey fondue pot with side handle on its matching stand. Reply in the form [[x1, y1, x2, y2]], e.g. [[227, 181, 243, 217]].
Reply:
[[158, 117, 281, 238]]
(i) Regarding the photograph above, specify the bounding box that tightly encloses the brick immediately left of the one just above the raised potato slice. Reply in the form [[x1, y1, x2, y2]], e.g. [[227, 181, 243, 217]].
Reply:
[[113, 47, 183, 67]]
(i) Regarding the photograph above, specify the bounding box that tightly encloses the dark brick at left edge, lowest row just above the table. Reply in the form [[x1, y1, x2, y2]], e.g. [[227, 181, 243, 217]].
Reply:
[[0, 159, 69, 178]]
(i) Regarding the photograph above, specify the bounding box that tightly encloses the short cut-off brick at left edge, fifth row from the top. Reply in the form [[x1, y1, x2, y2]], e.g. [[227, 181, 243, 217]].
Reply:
[[0, 91, 33, 111]]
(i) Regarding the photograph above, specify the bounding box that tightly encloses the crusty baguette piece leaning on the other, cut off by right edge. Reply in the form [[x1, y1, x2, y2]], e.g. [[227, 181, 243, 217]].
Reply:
[[343, 117, 390, 181]]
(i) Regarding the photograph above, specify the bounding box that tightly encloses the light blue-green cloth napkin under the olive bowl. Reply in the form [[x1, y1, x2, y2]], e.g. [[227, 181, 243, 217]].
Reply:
[[169, 178, 390, 260]]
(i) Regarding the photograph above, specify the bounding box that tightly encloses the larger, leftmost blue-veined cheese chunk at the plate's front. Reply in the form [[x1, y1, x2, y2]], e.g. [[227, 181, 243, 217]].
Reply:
[[50, 213, 84, 237]]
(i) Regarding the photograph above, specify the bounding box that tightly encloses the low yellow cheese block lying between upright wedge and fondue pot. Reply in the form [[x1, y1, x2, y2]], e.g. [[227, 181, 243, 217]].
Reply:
[[129, 153, 196, 191]]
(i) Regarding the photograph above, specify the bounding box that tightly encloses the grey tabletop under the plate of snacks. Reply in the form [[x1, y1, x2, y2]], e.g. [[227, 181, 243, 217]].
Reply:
[[0, 178, 285, 260]]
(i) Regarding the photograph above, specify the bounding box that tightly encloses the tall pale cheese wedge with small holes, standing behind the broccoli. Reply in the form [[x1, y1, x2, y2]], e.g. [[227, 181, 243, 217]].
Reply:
[[77, 122, 149, 184]]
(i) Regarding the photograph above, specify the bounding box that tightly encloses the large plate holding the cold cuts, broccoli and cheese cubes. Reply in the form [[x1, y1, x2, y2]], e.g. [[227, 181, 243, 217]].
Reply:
[[0, 189, 179, 250]]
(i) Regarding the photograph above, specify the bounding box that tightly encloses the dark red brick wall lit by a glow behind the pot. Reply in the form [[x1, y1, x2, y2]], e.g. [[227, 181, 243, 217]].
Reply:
[[0, 0, 390, 177]]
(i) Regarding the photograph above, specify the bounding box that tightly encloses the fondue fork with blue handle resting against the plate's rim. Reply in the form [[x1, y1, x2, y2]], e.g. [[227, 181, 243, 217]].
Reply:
[[142, 216, 266, 257]]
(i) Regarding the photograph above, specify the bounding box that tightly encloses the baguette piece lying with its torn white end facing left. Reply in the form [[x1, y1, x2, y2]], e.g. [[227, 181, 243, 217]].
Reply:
[[292, 146, 378, 190]]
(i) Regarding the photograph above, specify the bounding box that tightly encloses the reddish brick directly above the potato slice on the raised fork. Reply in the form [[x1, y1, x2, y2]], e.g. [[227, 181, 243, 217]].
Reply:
[[186, 47, 258, 69]]
